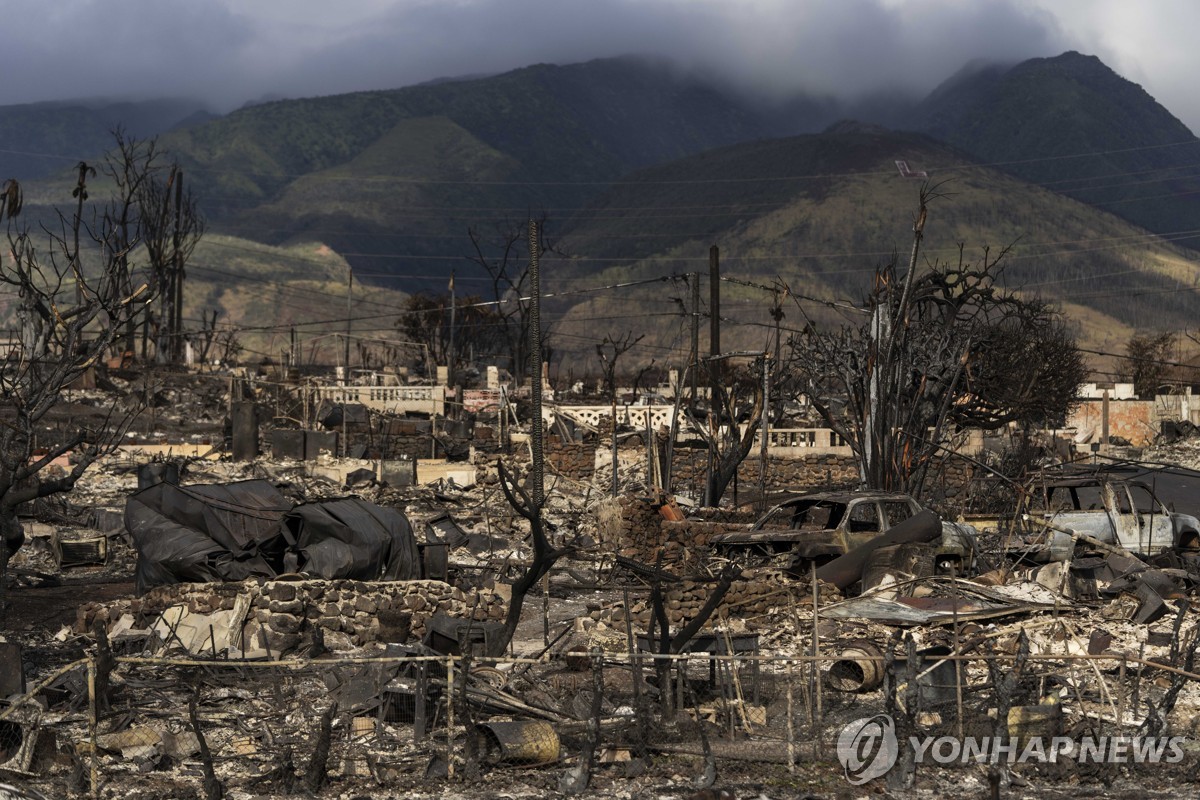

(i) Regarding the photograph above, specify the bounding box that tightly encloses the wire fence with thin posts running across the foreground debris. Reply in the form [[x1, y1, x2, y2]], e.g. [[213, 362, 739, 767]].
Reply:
[[0, 632, 1200, 798]]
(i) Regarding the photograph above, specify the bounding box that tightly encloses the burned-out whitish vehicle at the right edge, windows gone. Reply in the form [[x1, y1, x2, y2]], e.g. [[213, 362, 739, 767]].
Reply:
[[1025, 476, 1200, 561]]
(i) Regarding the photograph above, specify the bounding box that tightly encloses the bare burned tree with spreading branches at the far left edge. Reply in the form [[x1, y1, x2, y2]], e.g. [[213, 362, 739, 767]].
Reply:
[[0, 139, 180, 614]]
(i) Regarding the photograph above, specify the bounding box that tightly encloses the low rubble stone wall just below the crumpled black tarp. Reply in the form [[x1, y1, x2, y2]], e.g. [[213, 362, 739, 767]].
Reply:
[[76, 581, 506, 656]]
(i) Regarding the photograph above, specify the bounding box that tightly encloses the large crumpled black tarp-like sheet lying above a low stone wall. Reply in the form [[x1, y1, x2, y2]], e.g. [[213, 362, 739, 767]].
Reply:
[[125, 480, 421, 594]]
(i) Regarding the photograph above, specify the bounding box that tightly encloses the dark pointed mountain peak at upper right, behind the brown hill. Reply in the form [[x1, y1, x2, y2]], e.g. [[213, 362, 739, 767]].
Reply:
[[912, 53, 1200, 247]]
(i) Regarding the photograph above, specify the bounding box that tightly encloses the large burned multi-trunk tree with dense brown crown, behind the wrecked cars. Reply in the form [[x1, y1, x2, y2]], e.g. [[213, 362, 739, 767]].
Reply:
[[787, 187, 1086, 495]]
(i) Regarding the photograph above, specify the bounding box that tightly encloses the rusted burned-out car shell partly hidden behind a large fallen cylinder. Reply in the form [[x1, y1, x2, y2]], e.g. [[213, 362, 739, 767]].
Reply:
[[712, 492, 974, 572]]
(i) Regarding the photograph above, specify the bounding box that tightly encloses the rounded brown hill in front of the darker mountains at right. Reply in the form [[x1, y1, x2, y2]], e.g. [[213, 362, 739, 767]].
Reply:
[[552, 125, 1200, 367]]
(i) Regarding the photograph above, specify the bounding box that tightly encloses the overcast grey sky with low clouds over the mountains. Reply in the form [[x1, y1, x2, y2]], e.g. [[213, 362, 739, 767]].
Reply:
[[0, 0, 1200, 131]]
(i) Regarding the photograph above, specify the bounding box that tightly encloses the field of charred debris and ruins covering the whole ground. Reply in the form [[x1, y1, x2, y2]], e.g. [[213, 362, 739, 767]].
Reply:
[[0, 369, 1200, 798]]
